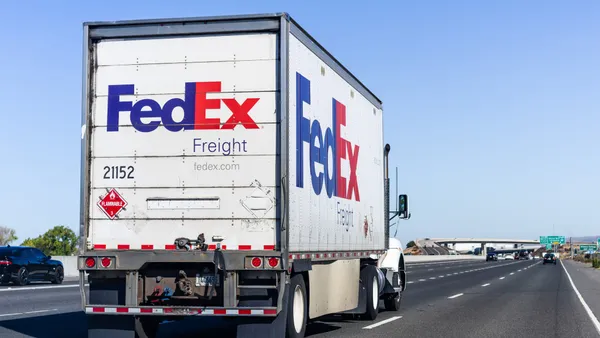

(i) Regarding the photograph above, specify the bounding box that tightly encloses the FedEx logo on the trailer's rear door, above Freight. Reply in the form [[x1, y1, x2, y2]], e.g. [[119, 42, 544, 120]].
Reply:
[[106, 82, 258, 133]]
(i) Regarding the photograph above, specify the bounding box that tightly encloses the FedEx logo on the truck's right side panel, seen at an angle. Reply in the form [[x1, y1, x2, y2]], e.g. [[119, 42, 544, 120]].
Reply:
[[296, 73, 360, 201]]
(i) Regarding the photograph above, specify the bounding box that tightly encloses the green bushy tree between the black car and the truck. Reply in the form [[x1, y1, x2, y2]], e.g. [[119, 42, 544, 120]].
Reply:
[[21, 225, 77, 256]]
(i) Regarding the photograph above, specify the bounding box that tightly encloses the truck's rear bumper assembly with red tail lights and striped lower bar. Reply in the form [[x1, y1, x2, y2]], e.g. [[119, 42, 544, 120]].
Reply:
[[78, 251, 287, 317]]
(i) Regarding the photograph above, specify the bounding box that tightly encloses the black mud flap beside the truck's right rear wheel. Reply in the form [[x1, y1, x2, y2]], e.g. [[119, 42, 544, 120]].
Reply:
[[236, 285, 289, 338]]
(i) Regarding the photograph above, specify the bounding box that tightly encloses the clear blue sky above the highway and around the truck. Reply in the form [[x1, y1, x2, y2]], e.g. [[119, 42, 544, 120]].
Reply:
[[0, 0, 600, 246]]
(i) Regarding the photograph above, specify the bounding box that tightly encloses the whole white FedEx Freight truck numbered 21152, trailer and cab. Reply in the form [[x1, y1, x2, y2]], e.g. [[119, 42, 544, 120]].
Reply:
[[78, 14, 408, 337]]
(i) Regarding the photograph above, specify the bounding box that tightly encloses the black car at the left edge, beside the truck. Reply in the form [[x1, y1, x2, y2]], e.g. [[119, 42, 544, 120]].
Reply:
[[0, 246, 65, 285]]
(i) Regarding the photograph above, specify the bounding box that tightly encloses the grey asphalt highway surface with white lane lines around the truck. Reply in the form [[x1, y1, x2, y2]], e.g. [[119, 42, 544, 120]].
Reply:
[[0, 259, 600, 338]]
